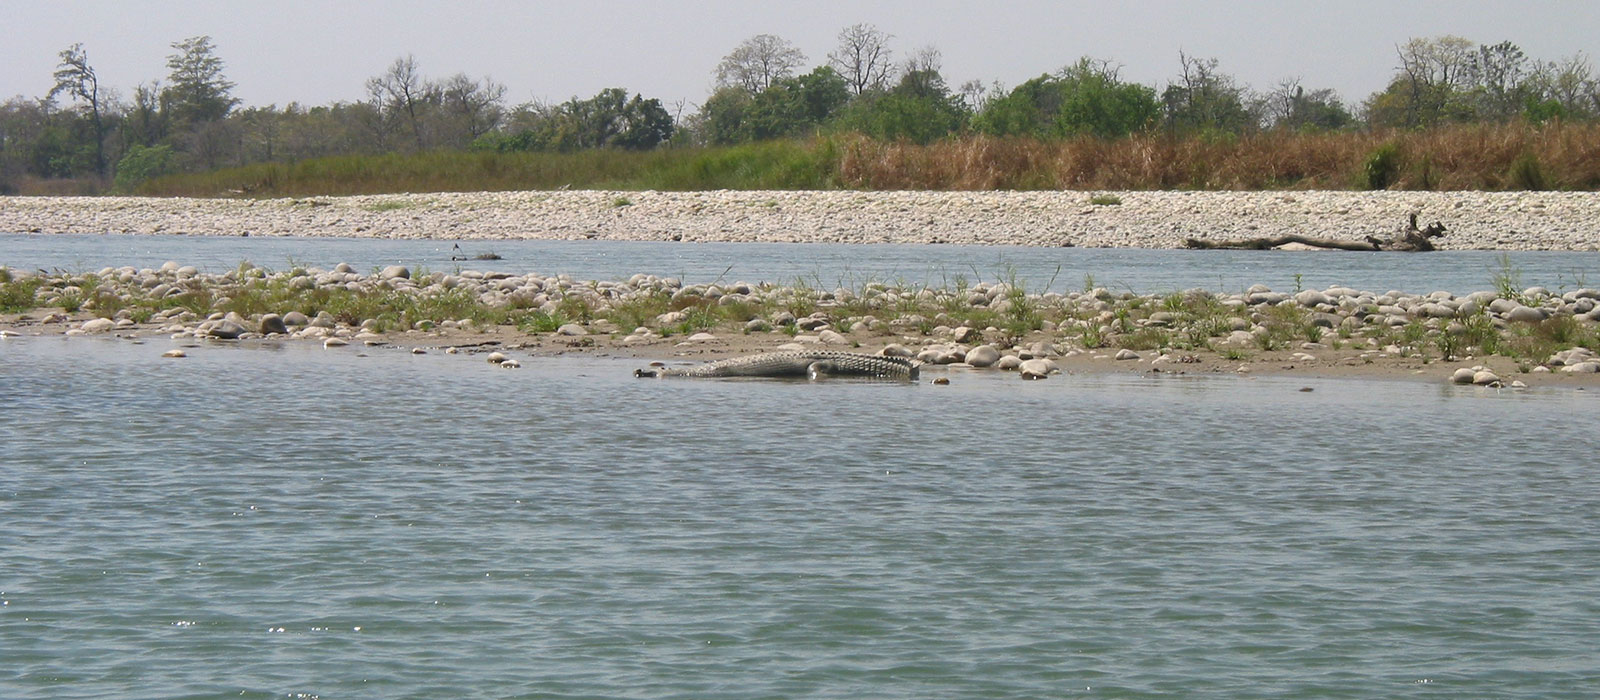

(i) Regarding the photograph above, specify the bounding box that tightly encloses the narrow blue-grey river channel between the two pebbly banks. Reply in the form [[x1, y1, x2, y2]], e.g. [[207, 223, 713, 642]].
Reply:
[[9, 233, 1600, 294]]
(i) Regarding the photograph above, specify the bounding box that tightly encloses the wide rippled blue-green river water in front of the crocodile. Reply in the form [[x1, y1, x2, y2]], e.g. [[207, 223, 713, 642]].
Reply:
[[0, 337, 1600, 698]]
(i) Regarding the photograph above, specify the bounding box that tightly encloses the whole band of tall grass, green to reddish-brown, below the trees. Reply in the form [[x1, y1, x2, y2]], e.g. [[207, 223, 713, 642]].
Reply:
[[139, 123, 1600, 197]]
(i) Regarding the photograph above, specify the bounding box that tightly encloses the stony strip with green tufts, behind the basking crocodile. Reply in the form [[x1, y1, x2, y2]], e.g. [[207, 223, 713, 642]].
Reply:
[[0, 262, 1600, 387]]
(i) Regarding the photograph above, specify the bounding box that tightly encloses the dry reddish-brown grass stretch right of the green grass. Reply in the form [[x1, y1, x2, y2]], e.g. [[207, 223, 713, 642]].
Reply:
[[838, 123, 1600, 190]]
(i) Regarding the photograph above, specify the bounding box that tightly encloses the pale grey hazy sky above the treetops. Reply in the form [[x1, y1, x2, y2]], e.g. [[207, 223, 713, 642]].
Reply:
[[0, 0, 1600, 109]]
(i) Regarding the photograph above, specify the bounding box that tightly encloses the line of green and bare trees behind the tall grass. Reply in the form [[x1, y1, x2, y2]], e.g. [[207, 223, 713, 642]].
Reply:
[[0, 24, 1600, 193]]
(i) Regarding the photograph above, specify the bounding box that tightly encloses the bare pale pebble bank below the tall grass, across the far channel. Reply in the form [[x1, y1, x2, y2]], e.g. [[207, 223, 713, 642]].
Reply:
[[9, 190, 1600, 251]]
